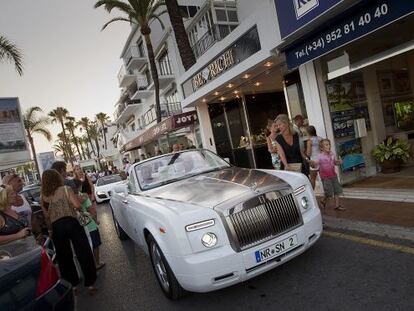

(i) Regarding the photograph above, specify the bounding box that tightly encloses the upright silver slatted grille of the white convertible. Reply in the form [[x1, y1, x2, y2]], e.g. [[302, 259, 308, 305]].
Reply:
[[229, 194, 302, 250]]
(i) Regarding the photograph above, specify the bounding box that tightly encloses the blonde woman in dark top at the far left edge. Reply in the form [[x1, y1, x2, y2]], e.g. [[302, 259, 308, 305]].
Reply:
[[0, 186, 30, 244]]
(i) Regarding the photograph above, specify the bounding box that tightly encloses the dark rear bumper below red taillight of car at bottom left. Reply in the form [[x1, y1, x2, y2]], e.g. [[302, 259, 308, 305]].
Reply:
[[34, 279, 75, 311]]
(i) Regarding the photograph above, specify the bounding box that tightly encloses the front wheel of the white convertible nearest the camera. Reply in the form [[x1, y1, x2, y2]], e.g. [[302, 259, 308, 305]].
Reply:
[[147, 235, 185, 300]]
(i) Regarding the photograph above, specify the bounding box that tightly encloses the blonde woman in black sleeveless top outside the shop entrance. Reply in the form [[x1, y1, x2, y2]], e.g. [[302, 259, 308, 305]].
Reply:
[[275, 114, 309, 176]]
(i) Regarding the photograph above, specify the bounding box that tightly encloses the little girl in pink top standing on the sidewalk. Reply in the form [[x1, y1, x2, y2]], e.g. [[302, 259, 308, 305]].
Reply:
[[311, 139, 345, 211]]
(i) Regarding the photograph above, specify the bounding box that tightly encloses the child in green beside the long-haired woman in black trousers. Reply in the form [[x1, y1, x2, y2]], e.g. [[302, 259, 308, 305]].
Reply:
[[74, 179, 105, 270]]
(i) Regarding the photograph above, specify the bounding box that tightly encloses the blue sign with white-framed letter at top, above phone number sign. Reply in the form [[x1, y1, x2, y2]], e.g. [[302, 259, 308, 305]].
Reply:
[[275, 0, 344, 39]]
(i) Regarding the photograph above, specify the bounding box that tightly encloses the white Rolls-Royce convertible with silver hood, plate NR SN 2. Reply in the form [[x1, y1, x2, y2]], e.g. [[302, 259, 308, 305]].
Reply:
[[110, 149, 322, 299]]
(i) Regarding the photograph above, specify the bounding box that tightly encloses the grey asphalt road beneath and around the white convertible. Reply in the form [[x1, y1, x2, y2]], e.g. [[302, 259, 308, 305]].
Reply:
[[77, 204, 414, 311]]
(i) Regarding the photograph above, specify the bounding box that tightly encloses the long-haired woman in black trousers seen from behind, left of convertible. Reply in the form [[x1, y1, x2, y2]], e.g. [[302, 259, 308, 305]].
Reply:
[[41, 170, 97, 295]]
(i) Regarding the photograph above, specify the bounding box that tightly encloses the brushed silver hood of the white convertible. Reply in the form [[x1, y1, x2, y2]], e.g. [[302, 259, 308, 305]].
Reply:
[[145, 167, 288, 208]]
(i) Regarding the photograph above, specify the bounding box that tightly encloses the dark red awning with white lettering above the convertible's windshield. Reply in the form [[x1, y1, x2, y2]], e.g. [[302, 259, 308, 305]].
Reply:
[[122, 111, 198, 152]]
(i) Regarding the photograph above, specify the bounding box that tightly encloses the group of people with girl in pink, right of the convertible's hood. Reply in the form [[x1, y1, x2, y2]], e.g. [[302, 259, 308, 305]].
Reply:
[[267, 114, 345, 211]]
